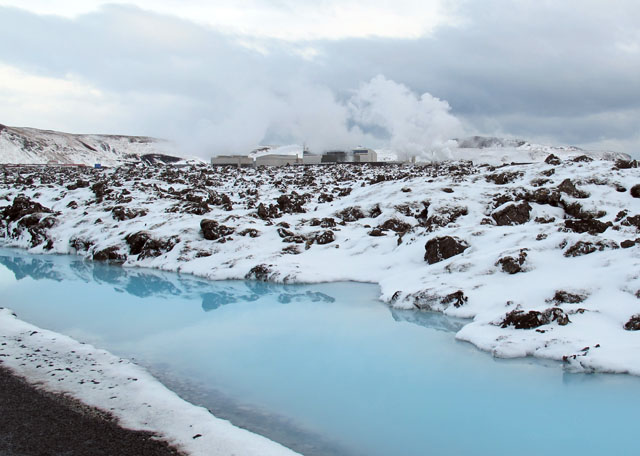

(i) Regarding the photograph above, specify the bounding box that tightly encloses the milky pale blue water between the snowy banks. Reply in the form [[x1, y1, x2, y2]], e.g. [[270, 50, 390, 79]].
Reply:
[[0, 250, 640, 456]]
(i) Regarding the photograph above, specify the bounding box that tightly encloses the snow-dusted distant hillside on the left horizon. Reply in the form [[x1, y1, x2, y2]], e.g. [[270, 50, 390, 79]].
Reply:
[[0, 124, 182, 166]]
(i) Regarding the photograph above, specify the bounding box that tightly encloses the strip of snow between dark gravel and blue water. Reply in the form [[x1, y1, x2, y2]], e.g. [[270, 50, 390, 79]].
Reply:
[[0, 308, 297, 456]]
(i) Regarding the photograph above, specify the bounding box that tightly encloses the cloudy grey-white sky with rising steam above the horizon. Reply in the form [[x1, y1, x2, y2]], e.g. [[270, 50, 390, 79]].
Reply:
[[0, 0, 640, 157]]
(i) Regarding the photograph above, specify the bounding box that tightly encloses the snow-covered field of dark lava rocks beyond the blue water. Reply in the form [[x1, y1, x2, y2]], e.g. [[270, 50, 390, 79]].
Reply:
[[0, 156, 640, 375]]
